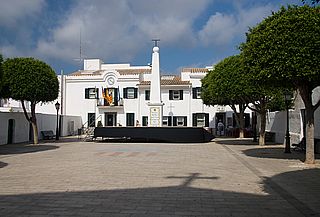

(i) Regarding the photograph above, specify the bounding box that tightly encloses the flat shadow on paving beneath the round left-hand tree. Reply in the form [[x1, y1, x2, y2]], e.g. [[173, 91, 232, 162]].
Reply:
[[0, 144, 59, 155]]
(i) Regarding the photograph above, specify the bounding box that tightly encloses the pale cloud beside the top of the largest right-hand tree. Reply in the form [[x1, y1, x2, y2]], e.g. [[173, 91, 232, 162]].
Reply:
[[198, 4, 275, 46]]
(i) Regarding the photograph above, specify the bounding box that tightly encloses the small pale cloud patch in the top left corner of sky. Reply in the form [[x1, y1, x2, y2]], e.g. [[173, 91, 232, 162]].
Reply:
[[0, 0, 44, 27]]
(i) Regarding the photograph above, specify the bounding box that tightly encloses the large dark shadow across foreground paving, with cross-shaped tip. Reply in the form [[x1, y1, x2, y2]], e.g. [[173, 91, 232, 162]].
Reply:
[[0, 169, 320, 217]]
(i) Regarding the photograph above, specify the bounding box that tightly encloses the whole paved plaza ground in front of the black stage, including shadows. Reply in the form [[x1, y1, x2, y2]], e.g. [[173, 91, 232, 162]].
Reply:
[[0, 139, 320, 217]]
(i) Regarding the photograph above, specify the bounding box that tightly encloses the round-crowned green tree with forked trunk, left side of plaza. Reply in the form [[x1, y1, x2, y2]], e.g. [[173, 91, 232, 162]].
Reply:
[[3, 58, 59, 144]]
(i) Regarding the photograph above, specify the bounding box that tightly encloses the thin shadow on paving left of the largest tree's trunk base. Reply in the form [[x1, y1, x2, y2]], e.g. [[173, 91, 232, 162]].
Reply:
[[242, 146, 320, 162]]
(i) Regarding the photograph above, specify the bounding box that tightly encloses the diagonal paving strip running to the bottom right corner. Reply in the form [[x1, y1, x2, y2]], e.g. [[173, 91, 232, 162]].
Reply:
[[222, 145, 320, 217]]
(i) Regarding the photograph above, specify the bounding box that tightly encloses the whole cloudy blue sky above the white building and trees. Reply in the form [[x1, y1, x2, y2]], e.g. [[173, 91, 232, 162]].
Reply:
[[0, 0, 301, 74]]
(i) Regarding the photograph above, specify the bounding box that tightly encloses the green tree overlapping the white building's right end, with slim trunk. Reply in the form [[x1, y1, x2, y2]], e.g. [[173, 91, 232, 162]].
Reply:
[[201, 55, 249, 138]]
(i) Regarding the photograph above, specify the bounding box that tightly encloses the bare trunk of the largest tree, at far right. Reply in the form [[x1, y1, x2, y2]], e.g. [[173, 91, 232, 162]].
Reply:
[[305, 107, 315, 164]]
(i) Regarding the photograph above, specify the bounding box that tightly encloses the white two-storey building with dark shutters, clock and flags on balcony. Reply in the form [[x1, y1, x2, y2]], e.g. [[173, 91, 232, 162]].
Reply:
[[62, 59, 244, 132]]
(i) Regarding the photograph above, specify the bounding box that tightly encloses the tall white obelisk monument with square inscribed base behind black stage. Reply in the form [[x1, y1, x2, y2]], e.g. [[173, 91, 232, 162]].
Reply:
[[148, 39, 164, 127]]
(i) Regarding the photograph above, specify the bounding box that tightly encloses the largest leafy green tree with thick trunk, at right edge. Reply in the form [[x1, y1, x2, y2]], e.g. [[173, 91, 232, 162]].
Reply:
[[241, 5, 320, 164]]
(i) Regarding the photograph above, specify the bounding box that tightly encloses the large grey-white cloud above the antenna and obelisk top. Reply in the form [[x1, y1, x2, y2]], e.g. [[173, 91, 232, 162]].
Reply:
[[37, 0, 208, 64]]
